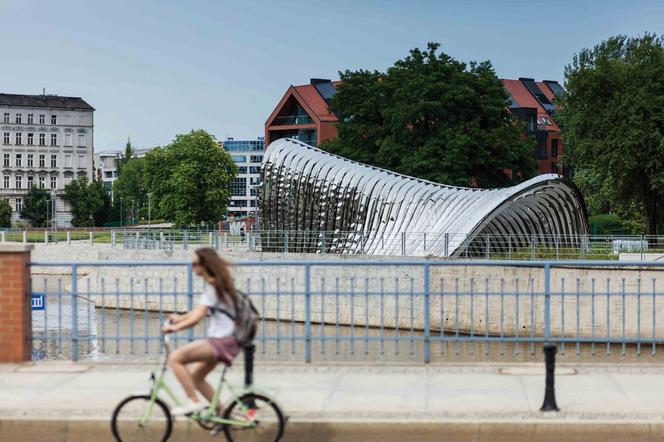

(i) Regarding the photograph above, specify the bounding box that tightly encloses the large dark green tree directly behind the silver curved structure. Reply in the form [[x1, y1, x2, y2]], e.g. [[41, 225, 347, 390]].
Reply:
[[321, 43, 536, 187]]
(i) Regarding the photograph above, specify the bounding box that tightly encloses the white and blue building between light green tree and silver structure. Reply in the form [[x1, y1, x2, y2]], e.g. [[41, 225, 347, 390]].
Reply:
[[220, 137, 265, 217]]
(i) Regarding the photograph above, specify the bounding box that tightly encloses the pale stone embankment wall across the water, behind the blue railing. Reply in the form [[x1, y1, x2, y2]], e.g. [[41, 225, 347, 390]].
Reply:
[[33, 245, 664, 339]]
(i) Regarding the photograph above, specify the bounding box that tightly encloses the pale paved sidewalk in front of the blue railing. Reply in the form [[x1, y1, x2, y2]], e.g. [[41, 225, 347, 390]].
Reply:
[[0, 362, 664, 442]]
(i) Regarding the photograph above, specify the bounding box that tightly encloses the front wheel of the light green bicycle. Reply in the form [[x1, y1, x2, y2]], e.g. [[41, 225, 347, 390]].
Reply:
[[111, 395, 173, 442]]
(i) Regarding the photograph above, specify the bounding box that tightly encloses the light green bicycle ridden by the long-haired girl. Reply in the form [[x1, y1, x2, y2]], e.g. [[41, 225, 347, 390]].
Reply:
[[111, 322, 286, 442]]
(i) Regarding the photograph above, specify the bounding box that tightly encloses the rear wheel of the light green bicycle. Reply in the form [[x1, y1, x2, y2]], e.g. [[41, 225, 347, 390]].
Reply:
[[224, 393, 285, 442]]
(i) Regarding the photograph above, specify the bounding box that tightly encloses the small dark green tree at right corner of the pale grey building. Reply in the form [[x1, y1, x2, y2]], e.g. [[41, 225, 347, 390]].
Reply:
[[62, 177, 111, 227]]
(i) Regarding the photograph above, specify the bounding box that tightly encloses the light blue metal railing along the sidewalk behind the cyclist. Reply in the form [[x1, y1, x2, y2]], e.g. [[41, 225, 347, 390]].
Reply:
[[31, 259, 664, 363]]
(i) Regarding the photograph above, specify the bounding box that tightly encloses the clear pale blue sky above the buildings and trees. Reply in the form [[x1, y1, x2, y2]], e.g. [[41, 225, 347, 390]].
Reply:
[[0, 0, 664, 151]]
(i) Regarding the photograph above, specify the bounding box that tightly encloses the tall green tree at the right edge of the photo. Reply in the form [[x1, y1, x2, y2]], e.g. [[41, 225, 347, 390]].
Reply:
[[556, 34, 664, 235]]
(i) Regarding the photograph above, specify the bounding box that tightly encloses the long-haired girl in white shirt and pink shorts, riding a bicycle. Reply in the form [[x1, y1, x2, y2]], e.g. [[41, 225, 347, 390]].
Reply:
[[162, 247, 240, 415]]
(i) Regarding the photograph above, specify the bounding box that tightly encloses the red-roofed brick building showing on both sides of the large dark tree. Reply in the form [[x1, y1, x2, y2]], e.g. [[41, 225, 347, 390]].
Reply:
[[265, 78, 564, 174]]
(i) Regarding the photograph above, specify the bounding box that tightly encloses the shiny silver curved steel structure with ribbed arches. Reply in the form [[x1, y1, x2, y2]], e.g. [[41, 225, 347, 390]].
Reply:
[[259, 138, 588, 256]]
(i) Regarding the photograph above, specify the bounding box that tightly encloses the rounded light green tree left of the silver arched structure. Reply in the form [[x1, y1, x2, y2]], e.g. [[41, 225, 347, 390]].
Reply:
[[144, 130, 237, 226]]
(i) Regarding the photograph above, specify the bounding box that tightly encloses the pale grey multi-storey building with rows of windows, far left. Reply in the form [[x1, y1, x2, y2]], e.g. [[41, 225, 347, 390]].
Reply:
[[0, 93, 95, 227]]
